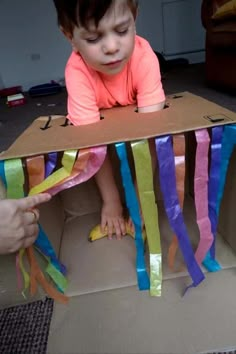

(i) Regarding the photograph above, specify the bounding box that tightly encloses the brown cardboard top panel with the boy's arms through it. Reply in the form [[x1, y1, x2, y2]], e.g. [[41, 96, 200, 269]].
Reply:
[[0, 92, 236, 160]]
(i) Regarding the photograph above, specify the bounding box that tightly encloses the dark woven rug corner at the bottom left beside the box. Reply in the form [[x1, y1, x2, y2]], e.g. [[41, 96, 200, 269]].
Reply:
[[0, 299, 53, 354]]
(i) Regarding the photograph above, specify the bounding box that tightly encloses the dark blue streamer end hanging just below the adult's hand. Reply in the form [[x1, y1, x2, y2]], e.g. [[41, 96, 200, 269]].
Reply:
[[34, 225, 66, 275]]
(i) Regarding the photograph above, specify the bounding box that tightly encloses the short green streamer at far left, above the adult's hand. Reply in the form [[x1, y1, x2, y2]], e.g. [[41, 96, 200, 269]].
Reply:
[[4, 159, 25, 199]]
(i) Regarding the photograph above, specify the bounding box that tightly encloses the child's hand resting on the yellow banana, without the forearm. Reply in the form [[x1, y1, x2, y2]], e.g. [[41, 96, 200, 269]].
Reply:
[[101, 200, 126, 240]]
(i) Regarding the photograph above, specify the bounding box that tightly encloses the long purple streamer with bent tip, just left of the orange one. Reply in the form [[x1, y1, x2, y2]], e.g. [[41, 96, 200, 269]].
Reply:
[[155, 136, 204, 291]]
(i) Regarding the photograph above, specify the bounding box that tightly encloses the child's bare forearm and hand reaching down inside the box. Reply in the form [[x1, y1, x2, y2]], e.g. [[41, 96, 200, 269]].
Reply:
[[95, 155, 126, 239]]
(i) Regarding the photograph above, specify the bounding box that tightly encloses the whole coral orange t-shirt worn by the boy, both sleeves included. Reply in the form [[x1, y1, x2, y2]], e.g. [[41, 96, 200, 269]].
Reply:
[[65, 36, 165, 125]]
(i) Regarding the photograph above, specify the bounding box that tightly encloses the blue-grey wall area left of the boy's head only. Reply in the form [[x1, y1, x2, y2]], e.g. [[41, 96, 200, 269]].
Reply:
[[0, 0, 70, 89]]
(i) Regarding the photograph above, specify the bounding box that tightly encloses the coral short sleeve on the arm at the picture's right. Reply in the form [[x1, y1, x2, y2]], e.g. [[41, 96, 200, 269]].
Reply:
[[134, 43, 165, 107]]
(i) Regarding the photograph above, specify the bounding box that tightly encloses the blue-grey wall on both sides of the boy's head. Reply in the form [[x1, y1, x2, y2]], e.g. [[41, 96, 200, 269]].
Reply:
[[0, 0, 204, 90]]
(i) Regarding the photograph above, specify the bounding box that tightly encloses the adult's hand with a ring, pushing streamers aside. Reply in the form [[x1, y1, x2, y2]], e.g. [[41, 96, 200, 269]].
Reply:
[[0, 193, 51, 254]]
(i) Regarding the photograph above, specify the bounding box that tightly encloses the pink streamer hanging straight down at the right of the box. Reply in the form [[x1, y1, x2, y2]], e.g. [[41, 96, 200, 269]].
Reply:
[[194, 129, 214, 265]]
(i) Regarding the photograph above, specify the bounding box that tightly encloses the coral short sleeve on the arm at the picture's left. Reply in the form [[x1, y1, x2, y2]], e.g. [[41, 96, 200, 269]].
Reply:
[[65, 63, 100, 125]]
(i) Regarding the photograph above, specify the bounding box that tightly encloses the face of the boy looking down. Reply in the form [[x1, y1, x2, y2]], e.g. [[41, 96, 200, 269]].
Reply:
[[72, 0, 135, 75]]
